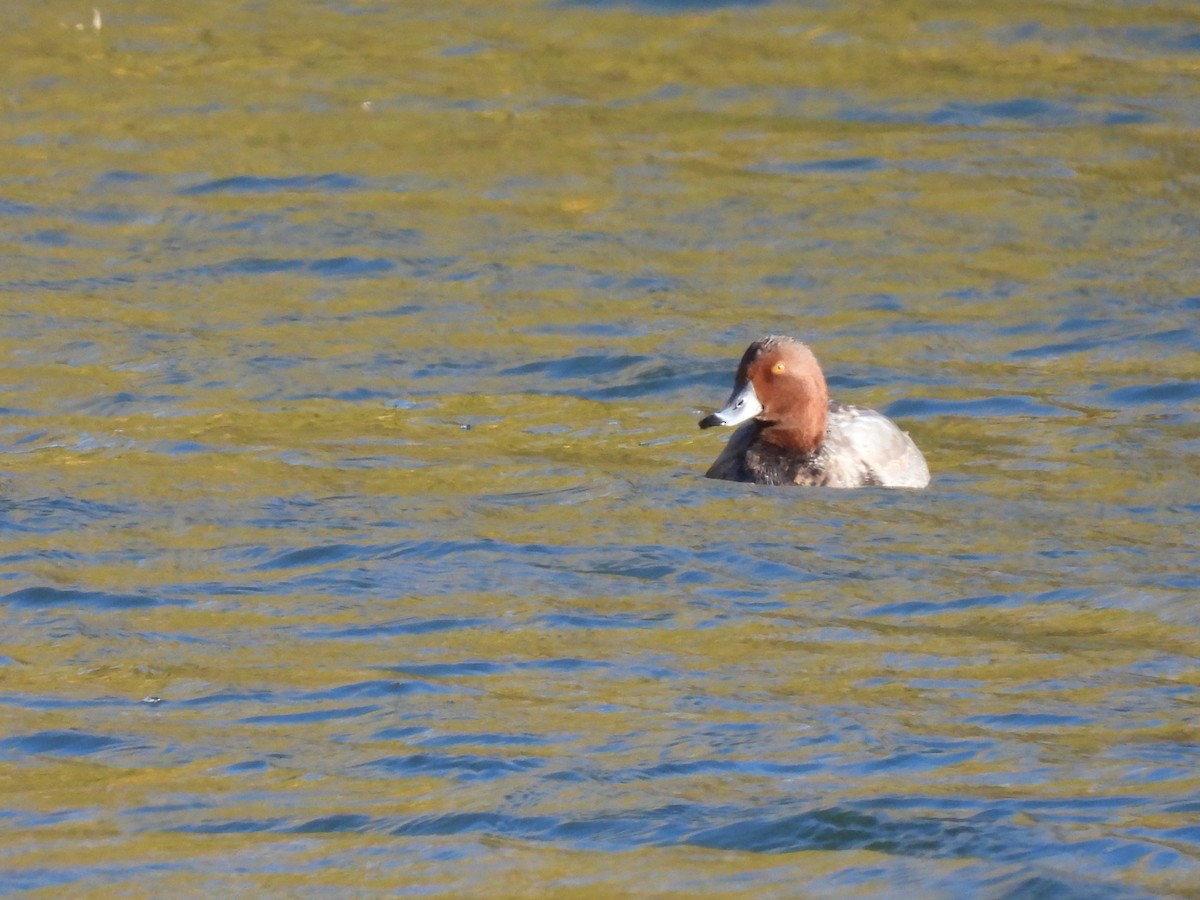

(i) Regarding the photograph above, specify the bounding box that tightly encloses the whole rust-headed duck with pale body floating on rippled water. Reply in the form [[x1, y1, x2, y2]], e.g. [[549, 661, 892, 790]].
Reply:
[[700, 335, 929, 488]]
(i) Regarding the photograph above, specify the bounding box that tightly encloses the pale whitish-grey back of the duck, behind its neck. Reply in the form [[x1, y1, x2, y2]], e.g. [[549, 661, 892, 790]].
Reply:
[[822, 401, 929, 487]]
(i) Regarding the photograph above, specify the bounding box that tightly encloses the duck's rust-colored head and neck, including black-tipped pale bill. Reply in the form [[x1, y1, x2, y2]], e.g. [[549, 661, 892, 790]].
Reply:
[[700, 335, 829, 454]]
